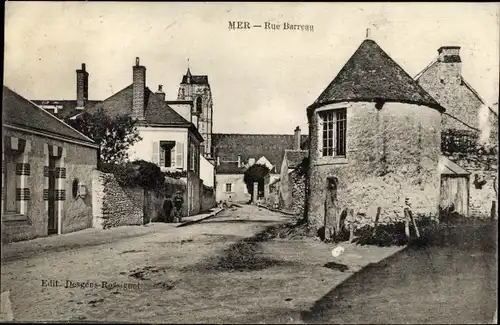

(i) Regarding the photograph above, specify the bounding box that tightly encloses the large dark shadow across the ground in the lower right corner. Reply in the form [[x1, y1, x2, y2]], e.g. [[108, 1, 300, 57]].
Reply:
[[301, 223, 498, 324]]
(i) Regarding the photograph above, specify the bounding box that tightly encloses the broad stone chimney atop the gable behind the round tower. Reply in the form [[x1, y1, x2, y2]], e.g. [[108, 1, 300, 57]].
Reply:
[[438, 46, 462, 85]]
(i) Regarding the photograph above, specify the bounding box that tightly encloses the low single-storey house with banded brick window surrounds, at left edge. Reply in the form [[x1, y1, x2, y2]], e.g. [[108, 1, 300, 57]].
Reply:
[[2, 86, 98, 242]]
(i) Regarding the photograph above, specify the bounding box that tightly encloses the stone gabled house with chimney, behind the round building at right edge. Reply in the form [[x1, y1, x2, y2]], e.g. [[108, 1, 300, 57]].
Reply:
[[415, 46, 498, 217]]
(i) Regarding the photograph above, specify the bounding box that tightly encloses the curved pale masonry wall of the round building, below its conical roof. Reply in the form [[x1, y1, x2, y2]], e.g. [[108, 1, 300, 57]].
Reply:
[[308, 103, 441, 229]]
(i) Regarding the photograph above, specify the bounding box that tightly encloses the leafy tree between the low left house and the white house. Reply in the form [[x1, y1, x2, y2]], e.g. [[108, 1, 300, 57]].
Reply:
[[65, 108, 142, 164]]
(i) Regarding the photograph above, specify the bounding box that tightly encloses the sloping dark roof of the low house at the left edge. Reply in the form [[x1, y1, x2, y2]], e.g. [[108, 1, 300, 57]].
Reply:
[[2, 86, 94, 144]]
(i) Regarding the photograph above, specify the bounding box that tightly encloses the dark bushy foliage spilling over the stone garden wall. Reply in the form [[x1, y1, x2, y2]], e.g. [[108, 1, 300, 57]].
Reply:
[[99, 160, 165, 189]]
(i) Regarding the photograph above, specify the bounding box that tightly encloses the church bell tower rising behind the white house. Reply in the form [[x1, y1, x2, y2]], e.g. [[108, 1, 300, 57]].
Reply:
[[177, 67, 213, 159]]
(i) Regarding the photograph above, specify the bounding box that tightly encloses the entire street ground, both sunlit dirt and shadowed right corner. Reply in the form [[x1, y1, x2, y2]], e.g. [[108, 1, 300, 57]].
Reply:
[[1, 205, 496, 323]]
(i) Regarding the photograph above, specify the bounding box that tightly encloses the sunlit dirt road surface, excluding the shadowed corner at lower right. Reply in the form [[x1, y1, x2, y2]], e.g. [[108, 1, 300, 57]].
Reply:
[[1, 206, 398, 323]]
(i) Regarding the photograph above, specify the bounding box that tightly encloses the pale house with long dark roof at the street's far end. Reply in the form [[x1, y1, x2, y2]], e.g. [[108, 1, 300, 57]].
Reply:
[[212, 129, 307, 202]]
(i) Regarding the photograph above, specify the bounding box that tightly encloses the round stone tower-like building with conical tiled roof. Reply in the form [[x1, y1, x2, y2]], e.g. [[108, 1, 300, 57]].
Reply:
[[306, 34, 445, 236]]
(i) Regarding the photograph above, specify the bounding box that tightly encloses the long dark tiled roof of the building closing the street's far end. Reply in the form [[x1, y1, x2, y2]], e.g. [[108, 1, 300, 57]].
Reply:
[[212, 133, 307, 174]]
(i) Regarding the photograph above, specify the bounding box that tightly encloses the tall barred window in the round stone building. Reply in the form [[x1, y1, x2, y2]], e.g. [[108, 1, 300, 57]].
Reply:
[[320, 109, 346, 157]]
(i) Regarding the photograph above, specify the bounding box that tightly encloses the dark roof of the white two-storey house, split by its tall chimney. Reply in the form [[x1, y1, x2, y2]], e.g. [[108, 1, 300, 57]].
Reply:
[[86, 84, 203, 140]]
